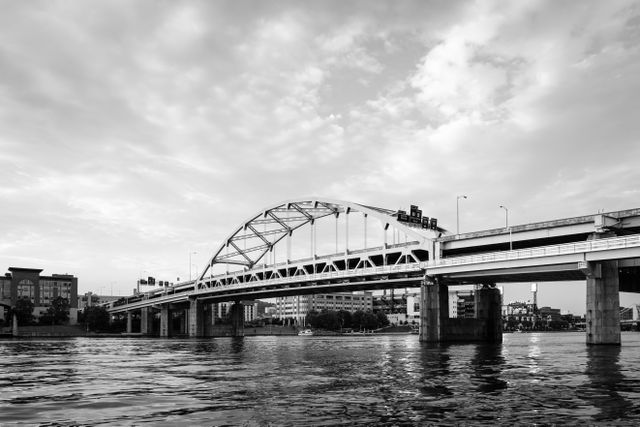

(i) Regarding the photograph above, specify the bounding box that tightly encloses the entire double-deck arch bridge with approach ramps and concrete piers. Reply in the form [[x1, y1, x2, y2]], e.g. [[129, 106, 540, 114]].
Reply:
[[109, 198, 640, 344]]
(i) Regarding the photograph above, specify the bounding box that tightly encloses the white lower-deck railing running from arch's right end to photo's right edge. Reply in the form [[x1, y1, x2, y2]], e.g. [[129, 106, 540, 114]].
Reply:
[[426, 235, 640, 267]]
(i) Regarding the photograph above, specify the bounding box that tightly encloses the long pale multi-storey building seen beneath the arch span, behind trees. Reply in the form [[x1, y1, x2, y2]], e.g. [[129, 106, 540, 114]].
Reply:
[[274, 292, 373, 325]]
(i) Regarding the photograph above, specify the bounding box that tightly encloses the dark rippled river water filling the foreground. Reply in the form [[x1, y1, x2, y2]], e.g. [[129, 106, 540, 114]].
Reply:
[[0, 333, 640, 426]]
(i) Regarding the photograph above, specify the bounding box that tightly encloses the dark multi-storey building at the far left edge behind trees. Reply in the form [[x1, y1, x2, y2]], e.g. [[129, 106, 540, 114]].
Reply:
[[0, 267, 78, 324]]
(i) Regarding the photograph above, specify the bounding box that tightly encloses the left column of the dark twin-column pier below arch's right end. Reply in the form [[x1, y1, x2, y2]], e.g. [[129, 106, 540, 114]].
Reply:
[[420, 277, 449, 342]]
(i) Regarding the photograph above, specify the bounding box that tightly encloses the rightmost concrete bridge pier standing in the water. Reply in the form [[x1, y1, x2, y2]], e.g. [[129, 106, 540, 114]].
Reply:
[[586, 261, 620, 345]]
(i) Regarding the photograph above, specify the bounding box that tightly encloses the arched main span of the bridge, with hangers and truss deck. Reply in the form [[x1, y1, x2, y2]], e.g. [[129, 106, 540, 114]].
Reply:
[[194, 198, 448, 299]]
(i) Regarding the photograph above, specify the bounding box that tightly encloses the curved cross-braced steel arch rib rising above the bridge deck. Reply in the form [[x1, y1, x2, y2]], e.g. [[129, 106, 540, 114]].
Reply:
[[198, 197, 449, 280]]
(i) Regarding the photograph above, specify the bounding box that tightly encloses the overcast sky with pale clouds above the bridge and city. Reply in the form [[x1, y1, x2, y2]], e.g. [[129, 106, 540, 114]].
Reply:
[[0, 0, 640, 313]]
